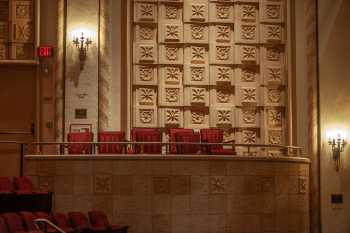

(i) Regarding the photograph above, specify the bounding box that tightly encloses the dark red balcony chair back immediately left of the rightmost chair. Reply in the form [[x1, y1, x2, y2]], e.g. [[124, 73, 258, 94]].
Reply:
[[176, 132, 200, 154]]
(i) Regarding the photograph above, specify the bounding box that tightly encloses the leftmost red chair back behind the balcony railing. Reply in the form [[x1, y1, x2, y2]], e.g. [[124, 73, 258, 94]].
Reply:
[[67, 132, 94, 154]]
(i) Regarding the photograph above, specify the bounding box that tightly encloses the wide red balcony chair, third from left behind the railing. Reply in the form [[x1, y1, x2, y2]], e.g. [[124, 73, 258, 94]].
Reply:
[[131, 128, 162, 154]]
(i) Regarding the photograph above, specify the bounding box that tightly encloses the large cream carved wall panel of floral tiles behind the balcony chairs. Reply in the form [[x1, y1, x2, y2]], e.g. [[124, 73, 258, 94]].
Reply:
[[132, 0, 288, 155]]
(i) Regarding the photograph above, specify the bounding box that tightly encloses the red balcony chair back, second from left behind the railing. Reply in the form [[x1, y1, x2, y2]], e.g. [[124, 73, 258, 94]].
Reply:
[[98, 131, 125, 154]]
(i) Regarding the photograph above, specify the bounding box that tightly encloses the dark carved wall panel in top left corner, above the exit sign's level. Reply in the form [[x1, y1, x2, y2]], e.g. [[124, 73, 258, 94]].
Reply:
[[0, 0, 35, 60]]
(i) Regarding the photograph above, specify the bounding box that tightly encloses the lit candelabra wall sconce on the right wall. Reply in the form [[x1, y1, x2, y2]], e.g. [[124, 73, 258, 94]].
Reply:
[[328, 132, 347, 171]]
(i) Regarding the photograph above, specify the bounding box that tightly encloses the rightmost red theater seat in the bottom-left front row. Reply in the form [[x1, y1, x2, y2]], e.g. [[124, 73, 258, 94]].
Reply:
[[88, 211, 128, 233]]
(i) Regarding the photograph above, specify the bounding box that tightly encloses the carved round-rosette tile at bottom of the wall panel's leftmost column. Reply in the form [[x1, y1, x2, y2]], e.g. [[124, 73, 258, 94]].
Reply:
[[134, 106, 158, 127]]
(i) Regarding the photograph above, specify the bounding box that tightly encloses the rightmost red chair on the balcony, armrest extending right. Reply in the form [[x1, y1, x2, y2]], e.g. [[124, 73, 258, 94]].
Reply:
[[200, 129, 236, 155]]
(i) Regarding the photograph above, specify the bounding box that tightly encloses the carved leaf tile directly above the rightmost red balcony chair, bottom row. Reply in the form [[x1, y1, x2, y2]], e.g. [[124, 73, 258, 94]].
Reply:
[[210, 107, 234, 127]]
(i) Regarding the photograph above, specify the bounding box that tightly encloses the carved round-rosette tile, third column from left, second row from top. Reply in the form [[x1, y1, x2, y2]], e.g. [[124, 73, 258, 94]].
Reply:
[[184, 23, 209, 44]]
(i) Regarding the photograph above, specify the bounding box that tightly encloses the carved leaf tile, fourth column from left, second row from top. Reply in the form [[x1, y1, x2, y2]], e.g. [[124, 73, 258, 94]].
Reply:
[[209, 24, 233, 44]]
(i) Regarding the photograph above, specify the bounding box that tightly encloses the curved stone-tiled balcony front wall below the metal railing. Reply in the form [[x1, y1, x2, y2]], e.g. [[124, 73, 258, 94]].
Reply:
[[25, 156, 309, 233]]
